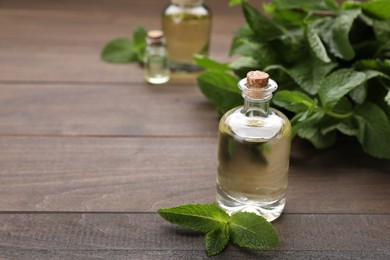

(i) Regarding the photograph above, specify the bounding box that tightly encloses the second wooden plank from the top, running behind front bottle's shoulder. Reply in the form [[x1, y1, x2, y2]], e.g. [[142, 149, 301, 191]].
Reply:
[[0, 83, 218, 136]]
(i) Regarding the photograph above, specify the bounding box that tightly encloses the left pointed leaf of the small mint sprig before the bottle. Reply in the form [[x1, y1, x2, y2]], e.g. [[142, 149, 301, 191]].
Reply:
[[157, 204, 229, 233]]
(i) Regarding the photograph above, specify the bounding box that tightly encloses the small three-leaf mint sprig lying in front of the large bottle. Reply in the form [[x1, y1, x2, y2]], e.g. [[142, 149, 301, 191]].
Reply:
[[158, 204, 280, 256]]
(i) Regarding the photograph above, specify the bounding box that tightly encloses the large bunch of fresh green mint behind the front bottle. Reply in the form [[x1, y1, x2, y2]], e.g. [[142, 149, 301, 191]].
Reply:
[[195, 0, 390, 159]]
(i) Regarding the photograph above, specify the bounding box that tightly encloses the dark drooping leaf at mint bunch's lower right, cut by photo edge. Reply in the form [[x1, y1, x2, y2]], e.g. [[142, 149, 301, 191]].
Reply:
[[355, 102, 390, 159]]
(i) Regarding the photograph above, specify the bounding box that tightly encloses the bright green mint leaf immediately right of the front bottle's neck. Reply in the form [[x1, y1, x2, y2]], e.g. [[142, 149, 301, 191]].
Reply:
[[273, 90, 317, 113]]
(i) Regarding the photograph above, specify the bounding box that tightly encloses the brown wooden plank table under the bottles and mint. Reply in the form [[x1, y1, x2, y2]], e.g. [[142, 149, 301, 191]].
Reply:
[[0, 0, 390, 259]]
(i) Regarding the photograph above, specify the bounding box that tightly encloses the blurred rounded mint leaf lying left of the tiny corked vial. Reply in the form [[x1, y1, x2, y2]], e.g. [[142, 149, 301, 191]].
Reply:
[[101, 38, 137, 63]]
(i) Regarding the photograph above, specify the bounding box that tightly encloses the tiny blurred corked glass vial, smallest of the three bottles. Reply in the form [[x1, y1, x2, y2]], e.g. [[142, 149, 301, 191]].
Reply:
[[144, 30, 169, 84]]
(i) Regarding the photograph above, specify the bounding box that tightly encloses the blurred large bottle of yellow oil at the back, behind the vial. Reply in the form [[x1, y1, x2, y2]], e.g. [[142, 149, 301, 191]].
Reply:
[[162, 0, 211, 72]]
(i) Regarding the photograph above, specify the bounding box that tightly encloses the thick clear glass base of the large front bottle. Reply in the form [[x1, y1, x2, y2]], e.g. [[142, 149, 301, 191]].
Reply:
[[217, 187, 286, 222]]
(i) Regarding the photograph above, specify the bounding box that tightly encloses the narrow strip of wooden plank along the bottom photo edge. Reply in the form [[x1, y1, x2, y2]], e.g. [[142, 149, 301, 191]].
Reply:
[[0, 248, 390, 260]]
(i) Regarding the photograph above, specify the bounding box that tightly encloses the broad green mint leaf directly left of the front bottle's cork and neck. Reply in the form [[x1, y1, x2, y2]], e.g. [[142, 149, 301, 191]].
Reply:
[[197, 70, 243, 114]]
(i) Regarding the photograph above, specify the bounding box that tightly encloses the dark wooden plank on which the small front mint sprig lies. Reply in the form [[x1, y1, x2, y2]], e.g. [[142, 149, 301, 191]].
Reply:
[[0, 214, 390, 259]]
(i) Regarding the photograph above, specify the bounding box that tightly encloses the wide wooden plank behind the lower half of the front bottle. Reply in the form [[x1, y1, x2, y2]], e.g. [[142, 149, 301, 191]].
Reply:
[[0, 136, 390, 214]]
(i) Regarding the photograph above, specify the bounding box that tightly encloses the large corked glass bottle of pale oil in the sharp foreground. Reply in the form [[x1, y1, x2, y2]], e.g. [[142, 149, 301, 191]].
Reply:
[[217, 71, 291, 221]]
